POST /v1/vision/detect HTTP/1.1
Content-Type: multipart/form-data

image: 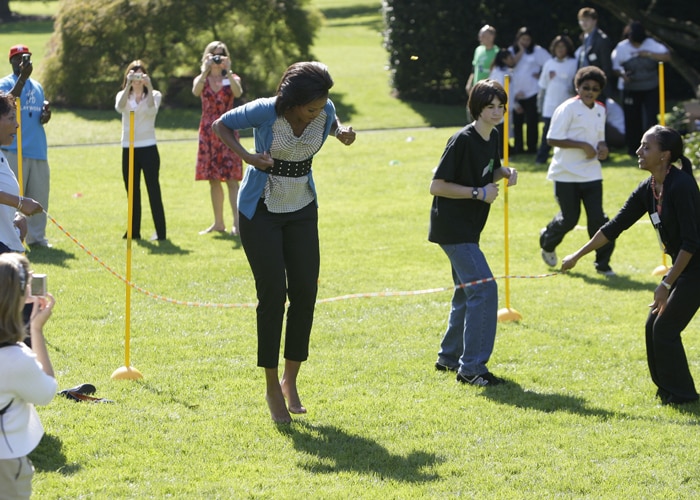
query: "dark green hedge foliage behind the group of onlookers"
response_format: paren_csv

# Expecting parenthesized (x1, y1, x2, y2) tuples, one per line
(382, 0, 700, 103)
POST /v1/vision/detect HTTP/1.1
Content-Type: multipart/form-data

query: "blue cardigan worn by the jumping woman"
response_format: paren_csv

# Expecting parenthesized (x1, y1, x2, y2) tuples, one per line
(221, 97, 335, 219)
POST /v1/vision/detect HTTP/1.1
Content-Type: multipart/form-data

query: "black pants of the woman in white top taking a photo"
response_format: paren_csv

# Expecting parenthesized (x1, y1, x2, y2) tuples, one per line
(122, 146, 166, 240)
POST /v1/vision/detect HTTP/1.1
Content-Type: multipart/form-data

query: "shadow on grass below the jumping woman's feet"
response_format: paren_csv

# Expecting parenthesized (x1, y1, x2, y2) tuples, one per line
(279, 421, 439, 483)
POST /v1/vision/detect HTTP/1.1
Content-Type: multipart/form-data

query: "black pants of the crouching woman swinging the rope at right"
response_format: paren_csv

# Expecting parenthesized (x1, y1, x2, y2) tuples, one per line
(646, 273, 700, 403)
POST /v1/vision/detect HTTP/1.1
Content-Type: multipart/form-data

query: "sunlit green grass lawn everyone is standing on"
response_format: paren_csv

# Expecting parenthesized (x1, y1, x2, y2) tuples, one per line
(5, 0, 700, 499)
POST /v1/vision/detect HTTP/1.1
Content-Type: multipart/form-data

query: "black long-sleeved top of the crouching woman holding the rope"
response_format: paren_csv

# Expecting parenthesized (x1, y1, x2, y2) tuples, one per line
(600, 167, 700, 272)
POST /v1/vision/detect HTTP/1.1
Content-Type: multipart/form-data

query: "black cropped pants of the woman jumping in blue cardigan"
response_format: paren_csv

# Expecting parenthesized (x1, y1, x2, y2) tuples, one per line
(240, 201, 320, 368)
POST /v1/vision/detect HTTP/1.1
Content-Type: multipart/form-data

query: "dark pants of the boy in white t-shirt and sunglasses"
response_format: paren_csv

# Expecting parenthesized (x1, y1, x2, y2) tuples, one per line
(540, 181, 615, 271)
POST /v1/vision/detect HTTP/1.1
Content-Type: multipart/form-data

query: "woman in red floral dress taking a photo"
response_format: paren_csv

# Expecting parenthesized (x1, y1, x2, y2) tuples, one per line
(192, 41, 243, 236)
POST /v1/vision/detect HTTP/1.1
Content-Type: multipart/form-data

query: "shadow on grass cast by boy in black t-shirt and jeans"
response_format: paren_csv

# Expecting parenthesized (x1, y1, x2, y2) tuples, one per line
(482, 380, 615, 419)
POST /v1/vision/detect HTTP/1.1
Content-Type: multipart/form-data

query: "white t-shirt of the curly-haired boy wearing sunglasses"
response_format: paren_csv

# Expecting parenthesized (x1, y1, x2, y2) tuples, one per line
(547, 96, 605, 182)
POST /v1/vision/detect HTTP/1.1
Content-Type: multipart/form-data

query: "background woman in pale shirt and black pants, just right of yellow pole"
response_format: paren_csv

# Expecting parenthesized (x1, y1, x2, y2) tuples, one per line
(510, 27, 550, 155)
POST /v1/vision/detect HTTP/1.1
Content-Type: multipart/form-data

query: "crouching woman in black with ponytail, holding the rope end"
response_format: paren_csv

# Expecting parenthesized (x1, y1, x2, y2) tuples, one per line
(561, 125, 700, 404)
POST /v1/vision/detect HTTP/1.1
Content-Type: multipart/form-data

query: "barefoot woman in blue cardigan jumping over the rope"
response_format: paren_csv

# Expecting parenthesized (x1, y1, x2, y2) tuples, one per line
(212, 62, 355, 423)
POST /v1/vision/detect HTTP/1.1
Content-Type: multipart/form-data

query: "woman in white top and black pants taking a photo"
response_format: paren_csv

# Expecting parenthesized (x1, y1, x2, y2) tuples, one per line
(114, 60, 166, 240)
